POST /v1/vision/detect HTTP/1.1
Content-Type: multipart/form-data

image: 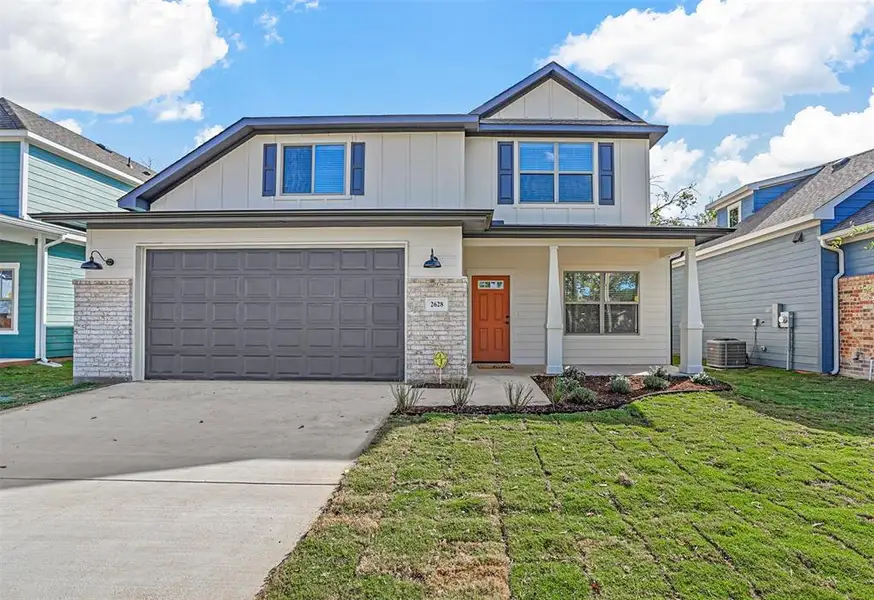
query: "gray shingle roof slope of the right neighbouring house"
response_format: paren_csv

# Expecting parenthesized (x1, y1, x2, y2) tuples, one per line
(703, 149, 874, 247)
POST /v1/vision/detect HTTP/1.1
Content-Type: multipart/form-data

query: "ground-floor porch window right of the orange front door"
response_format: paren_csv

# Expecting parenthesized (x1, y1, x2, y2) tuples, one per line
(564, 271, 640, 334)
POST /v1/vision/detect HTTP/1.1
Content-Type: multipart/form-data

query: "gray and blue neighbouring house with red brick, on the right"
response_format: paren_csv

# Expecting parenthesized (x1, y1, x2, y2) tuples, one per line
(672, 150, 874, 377)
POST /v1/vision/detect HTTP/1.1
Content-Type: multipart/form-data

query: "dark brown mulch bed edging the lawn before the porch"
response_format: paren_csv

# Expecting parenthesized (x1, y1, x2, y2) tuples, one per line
(392, 375, 731, 416)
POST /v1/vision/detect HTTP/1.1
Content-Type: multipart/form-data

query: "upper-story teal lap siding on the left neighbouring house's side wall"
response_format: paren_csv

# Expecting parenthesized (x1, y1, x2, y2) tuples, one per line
(27, 144, 132, 213)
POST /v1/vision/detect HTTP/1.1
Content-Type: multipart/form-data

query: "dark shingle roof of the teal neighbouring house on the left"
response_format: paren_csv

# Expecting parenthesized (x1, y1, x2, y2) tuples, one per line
(0, 98, 155, 181)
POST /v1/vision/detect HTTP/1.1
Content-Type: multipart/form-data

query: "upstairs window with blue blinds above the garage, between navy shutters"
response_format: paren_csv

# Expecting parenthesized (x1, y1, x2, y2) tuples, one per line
(282, 144, 346, 194)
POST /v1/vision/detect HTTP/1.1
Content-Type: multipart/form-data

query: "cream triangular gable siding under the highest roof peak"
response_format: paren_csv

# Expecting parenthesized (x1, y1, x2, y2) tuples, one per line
(488, 79, 612, 120)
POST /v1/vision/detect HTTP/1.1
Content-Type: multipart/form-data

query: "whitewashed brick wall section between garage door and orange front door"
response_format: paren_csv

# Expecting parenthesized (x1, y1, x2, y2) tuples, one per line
(406, 277, 468, 380)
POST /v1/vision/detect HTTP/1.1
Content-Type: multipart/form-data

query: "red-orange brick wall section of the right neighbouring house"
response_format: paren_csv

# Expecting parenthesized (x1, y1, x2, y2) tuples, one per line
(838, 274, 874, 378)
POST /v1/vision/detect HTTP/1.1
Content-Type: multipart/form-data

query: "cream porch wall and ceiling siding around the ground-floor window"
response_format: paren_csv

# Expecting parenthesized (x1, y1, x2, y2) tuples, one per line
(464, 246, 670, 367)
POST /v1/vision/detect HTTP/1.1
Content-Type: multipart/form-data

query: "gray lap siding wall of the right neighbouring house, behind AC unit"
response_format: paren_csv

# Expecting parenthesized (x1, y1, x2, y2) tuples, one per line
(671, 227, 822, 372)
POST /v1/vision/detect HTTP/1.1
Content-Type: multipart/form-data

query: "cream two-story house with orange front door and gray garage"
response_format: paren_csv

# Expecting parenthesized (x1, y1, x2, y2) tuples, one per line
(34, 64, 728, 380)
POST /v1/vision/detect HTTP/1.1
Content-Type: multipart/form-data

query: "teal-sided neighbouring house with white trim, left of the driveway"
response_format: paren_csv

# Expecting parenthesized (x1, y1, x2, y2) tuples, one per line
(0, 98, 152, 360)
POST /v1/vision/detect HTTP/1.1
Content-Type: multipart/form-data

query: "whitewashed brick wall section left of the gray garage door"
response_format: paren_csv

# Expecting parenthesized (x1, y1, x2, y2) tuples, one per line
(73, 279, 133, 383)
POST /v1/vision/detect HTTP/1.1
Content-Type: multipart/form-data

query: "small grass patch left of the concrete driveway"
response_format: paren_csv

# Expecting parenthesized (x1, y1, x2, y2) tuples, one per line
(0, 361, 97, 410)
